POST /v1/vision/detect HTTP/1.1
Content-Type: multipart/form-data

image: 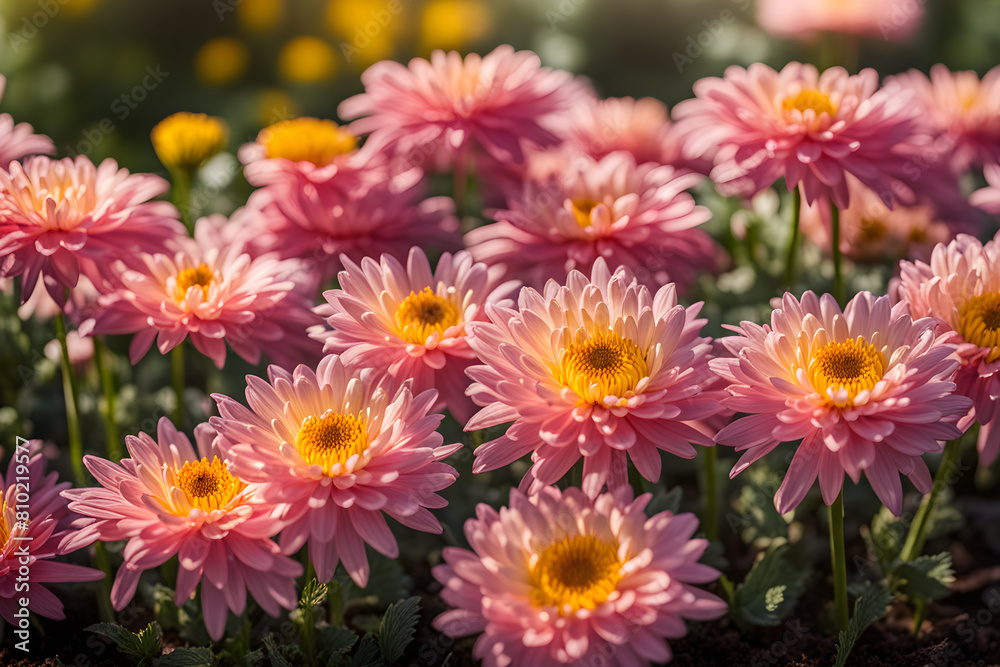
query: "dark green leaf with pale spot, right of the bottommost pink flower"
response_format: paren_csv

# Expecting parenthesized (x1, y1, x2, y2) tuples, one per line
(732, 545, 809, 625)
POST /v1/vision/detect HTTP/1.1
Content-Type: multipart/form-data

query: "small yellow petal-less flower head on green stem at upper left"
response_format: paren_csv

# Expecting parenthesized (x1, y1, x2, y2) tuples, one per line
(149, 111, 229, 170)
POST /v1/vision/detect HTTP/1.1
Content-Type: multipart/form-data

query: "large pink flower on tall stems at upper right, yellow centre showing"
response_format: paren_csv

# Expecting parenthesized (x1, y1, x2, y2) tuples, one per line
(674, 62, 915, 209)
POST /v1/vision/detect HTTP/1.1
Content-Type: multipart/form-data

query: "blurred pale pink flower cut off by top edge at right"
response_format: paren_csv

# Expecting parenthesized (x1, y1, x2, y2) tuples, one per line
(757, 0, 924, 41)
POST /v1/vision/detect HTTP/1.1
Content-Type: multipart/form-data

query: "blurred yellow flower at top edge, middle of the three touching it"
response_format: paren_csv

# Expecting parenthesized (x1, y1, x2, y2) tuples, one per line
(326, 0, 396, 68)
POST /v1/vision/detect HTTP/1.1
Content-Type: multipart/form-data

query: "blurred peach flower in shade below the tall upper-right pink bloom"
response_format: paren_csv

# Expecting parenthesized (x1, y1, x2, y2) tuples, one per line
(800, 176, 969, 264)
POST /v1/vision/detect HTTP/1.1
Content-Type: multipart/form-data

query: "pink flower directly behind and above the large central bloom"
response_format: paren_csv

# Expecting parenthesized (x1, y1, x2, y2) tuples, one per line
(465, 152, 717, 289)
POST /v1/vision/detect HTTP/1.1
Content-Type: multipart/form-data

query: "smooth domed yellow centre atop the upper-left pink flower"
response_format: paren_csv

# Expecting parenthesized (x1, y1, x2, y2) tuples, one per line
(257, 118, 358, 167)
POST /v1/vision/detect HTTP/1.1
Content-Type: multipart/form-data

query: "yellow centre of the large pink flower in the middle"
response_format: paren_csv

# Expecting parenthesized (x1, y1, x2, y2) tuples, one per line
(556, 331, 647, 403)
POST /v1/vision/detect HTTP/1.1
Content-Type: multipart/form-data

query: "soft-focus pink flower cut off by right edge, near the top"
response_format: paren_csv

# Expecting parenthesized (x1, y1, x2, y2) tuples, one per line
(885, 63, 1000, 173)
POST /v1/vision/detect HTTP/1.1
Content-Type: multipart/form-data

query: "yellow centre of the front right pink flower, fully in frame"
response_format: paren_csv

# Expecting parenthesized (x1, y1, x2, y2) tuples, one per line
(807, 336, 885, 408)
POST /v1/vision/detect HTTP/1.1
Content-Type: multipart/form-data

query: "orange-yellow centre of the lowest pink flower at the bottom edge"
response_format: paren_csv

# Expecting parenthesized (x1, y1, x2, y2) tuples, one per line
(530, 535, 622, 614)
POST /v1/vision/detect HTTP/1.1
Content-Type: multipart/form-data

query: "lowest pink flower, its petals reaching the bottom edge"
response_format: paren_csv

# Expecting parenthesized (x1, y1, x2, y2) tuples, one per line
(433, 487, 726, 667)
